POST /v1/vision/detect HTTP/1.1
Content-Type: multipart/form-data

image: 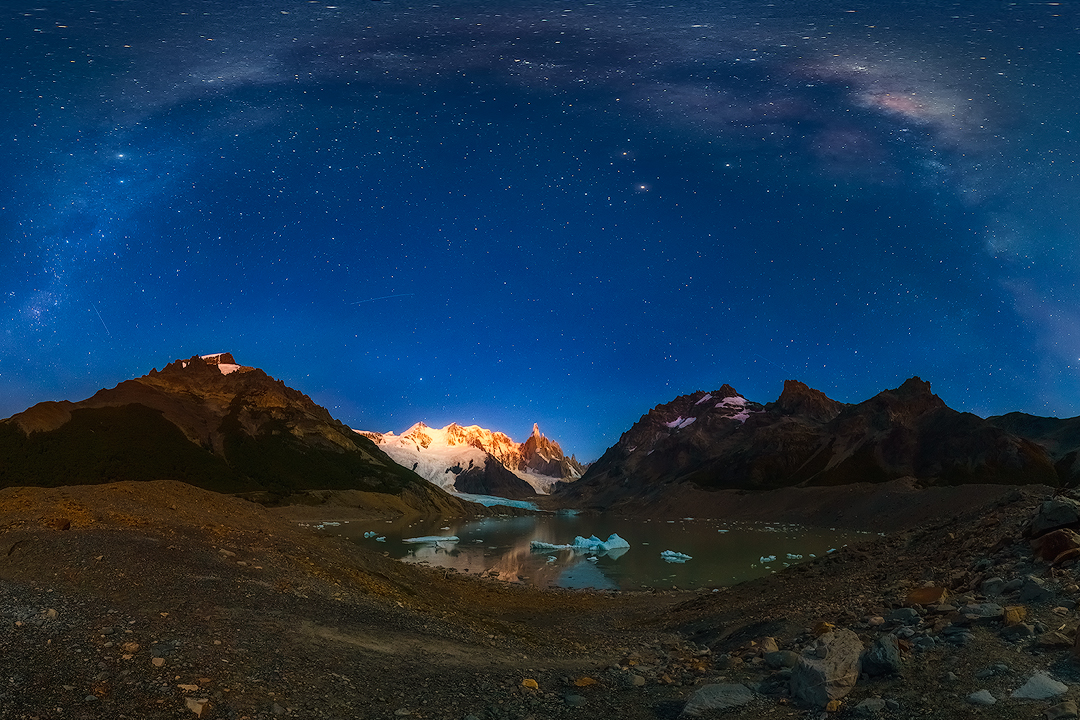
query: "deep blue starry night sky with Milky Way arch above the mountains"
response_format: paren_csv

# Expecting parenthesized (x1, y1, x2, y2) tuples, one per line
(0, 0, 1080, 460)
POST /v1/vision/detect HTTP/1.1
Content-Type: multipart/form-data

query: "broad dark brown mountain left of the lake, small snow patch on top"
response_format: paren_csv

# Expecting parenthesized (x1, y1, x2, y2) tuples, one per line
(0, 353, 438, 505)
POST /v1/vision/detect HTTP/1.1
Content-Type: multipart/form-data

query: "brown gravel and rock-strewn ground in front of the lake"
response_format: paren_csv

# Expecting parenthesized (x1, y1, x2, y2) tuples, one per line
(6, 481, 1080, 720)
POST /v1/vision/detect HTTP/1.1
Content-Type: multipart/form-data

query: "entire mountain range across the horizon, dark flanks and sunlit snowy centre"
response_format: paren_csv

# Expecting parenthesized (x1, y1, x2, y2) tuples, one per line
(0, 353, 1080, 513)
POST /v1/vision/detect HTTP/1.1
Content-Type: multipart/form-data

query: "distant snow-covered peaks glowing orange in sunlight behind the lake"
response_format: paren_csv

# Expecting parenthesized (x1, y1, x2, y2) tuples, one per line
(362, 422, 583, 500)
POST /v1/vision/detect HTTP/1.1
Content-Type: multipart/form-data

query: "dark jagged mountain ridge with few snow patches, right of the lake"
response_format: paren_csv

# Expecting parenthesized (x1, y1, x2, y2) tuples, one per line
(557, 377, 1080, 507)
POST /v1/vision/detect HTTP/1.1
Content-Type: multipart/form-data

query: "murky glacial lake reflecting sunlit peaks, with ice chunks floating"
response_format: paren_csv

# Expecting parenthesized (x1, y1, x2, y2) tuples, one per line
(313, 514, 870, 590)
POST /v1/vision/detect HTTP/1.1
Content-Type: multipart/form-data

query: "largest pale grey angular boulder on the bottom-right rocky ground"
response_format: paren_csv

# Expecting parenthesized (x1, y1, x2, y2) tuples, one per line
(791, 629, 863, 708)
